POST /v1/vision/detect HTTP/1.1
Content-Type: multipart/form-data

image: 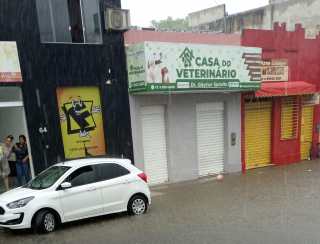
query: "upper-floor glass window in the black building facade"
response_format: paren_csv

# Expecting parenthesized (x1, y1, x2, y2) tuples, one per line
(37, 0, 102, 43)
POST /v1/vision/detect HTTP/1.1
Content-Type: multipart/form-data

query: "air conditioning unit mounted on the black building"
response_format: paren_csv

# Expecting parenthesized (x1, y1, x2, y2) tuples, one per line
(105, 8, 130, 31)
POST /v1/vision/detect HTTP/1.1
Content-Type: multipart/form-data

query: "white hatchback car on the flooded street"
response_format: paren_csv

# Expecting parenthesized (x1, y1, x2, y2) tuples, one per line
(0, 158, 151, 233)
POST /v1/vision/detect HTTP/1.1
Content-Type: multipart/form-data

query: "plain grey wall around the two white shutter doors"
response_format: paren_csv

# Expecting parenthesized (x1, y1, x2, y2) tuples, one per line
(130, 93, 241, 182)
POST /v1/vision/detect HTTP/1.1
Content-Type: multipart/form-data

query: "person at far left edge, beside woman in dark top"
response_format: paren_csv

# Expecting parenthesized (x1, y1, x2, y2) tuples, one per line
(0, 136, 12, 191)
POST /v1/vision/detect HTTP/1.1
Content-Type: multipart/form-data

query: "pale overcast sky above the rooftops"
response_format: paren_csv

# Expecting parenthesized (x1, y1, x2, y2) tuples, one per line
(121, 0, 269, 27)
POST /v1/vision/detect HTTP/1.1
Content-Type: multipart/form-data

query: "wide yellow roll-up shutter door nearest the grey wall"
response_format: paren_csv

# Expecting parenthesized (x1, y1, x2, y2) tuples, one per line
(245, 100, 272, 169)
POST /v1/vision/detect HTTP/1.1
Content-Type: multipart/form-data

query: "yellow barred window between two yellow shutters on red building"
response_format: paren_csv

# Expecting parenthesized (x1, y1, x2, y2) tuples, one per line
(281, 97, 299, 140)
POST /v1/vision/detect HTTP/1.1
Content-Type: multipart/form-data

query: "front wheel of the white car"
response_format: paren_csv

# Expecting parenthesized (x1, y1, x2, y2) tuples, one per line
(33, 210, 57, 233)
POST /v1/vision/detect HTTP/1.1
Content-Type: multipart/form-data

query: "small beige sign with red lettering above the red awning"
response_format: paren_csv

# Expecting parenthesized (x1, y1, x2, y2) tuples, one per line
(262, 59, 289, 81)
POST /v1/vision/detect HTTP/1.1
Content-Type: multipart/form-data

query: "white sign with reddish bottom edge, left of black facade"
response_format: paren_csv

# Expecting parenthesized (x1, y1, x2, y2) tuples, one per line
(0, 42, 22, 83)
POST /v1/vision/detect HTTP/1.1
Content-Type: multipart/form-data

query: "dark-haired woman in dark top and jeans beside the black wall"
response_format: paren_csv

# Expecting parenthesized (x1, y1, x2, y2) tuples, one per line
(13, 135, 30, 186)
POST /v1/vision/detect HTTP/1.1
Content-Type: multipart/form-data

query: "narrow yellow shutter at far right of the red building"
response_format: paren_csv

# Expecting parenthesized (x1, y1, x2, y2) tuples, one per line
(300, 96, 314, 160)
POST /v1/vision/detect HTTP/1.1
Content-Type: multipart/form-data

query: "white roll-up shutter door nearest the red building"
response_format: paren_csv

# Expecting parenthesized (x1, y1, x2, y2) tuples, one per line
(197, 103, 224, 176)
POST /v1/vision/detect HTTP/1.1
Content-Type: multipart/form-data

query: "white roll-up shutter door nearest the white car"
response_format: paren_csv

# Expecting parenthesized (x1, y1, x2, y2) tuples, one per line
(141, 106, 168, 185)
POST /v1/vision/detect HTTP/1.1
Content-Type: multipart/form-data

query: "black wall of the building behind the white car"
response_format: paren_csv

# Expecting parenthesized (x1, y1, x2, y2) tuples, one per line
(0, 0, 133, 173)
